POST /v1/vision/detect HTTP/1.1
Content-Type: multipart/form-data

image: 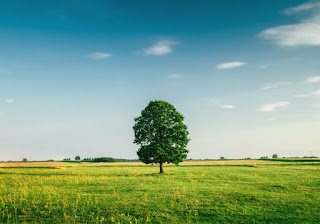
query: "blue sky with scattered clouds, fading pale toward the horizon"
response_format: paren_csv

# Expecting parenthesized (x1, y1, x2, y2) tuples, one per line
(0, 0, 320, 161)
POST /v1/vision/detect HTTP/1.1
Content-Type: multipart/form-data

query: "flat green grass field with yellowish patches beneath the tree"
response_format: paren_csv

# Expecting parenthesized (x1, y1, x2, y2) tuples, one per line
(0, 160, 320, 223)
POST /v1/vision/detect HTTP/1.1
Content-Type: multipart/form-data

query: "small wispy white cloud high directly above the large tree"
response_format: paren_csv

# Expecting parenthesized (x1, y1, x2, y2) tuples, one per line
(140, 40, 179, 56)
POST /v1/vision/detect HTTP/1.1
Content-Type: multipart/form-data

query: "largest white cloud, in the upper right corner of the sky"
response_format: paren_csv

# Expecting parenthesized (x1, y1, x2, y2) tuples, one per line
(259, 1, 320, 47)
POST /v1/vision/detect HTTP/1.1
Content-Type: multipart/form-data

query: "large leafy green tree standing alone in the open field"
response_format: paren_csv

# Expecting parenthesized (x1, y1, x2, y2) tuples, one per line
(133, 100, 190, 173)
